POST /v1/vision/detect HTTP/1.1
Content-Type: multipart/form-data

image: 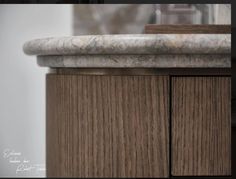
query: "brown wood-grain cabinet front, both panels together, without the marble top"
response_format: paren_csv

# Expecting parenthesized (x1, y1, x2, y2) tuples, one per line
(47, 74, 231, 178)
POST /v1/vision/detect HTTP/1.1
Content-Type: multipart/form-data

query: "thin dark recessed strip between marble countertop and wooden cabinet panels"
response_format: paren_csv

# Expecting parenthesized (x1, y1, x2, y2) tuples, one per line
(50, 68, 231, 76)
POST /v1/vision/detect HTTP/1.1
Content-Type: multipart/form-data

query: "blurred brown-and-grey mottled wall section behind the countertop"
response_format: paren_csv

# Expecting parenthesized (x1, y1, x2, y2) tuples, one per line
(74, 4, 155, 35)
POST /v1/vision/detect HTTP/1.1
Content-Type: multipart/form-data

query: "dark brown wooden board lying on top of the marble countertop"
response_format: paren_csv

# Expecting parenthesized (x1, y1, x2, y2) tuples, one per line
(145, 24, 231, 34)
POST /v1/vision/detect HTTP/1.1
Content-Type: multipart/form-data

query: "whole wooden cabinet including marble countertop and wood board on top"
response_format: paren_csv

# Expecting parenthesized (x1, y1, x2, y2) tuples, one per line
(23, 24, 231, 178)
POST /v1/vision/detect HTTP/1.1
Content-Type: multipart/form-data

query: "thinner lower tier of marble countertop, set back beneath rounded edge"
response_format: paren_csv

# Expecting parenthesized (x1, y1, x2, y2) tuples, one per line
(37, 54, 231, 68)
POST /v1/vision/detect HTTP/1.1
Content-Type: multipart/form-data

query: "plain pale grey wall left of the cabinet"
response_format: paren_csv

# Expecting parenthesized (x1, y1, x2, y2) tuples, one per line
(0, 5, 72, 177)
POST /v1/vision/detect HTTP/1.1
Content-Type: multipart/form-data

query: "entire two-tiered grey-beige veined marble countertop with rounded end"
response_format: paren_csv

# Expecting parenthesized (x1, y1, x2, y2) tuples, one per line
(23, 34, 231, 68)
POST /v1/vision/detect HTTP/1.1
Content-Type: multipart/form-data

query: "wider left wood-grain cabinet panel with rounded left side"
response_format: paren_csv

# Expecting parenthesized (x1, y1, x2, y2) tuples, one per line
(46, 74, 169, 177)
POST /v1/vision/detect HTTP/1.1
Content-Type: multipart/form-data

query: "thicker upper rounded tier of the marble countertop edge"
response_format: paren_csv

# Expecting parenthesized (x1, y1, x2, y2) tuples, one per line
(23, 34, 231, 55)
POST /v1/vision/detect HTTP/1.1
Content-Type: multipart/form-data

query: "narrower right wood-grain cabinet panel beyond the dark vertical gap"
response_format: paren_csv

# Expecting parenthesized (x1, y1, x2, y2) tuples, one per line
(171, 77, 231, 176)
